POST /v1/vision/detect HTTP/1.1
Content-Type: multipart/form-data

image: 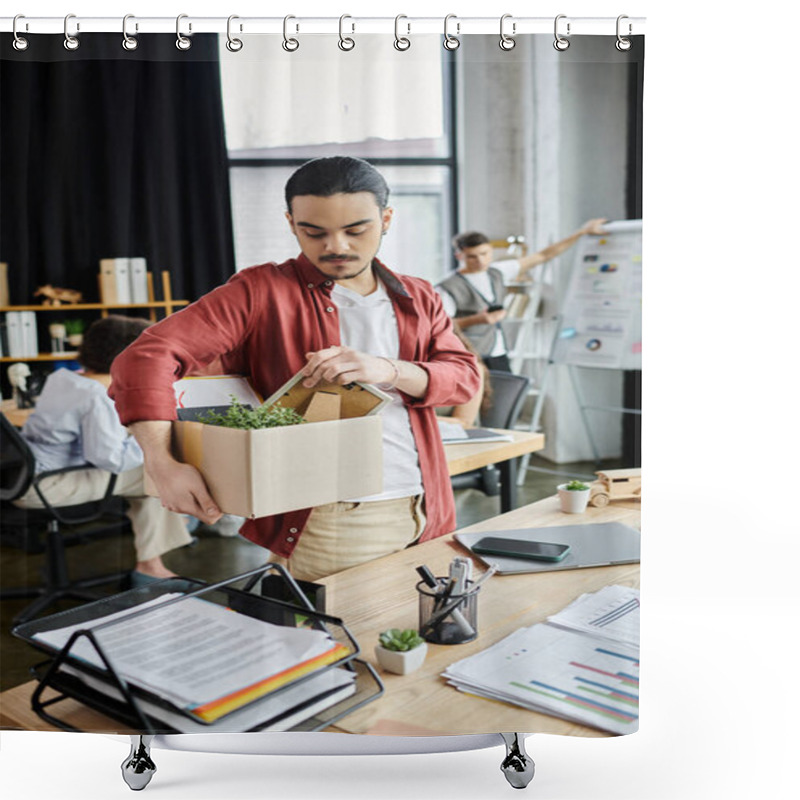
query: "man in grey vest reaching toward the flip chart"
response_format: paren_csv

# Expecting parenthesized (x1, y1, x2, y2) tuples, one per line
(436, 219, 606, 372)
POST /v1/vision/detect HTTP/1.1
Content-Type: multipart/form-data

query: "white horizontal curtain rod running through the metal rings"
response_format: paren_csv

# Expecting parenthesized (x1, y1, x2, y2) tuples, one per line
(0, 14, 645, 38)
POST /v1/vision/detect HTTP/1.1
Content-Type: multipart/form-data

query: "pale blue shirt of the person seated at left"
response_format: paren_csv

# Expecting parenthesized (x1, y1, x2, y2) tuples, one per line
(22, 369, 143, 473)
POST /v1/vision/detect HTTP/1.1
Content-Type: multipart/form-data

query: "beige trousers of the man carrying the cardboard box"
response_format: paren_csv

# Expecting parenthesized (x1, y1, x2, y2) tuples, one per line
(270, 495, 425, 581)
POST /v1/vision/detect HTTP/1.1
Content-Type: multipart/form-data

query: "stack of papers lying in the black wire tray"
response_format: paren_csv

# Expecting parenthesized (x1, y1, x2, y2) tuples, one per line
(35, 594, 355, 733)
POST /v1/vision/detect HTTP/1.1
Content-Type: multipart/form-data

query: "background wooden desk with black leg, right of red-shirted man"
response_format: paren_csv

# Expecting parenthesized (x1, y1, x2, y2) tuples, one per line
(444, 430, 544, 513)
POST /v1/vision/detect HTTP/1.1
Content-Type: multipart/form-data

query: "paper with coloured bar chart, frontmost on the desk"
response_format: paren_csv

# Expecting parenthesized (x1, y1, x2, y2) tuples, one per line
(444, 584, 639, 734)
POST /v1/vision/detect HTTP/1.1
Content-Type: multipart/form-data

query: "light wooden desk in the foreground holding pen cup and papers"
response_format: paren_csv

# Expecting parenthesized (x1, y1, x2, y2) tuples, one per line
(0, 497, 640, 736)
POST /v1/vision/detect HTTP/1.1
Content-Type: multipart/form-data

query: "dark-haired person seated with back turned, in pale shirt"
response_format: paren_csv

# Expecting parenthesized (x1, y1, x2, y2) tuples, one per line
(15, 316, 192, 586)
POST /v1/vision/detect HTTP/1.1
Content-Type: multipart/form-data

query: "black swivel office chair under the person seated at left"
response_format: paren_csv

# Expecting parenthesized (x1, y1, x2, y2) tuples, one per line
(0, 414, 130, 625)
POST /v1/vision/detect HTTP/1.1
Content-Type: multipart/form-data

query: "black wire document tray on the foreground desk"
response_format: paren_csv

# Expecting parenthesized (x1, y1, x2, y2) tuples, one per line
(13, 564, 383, 734)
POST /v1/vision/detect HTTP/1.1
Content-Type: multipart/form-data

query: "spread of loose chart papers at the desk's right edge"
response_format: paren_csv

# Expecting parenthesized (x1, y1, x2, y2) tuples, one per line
(443, 586, 639, 734)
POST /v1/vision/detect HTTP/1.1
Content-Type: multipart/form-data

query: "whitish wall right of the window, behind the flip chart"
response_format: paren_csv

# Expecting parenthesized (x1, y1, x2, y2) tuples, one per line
(459, 36, 628, 463)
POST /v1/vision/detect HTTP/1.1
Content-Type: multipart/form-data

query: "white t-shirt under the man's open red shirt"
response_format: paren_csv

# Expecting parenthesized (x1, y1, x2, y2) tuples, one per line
(331, 281, 422, 502)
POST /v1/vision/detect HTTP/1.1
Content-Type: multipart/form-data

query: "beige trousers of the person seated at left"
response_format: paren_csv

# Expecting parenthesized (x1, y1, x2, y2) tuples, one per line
(14, 467, 192, 561)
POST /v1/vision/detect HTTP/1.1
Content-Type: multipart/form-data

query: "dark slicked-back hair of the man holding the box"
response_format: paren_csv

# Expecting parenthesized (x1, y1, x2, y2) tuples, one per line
(285, 156, 389, 214)
